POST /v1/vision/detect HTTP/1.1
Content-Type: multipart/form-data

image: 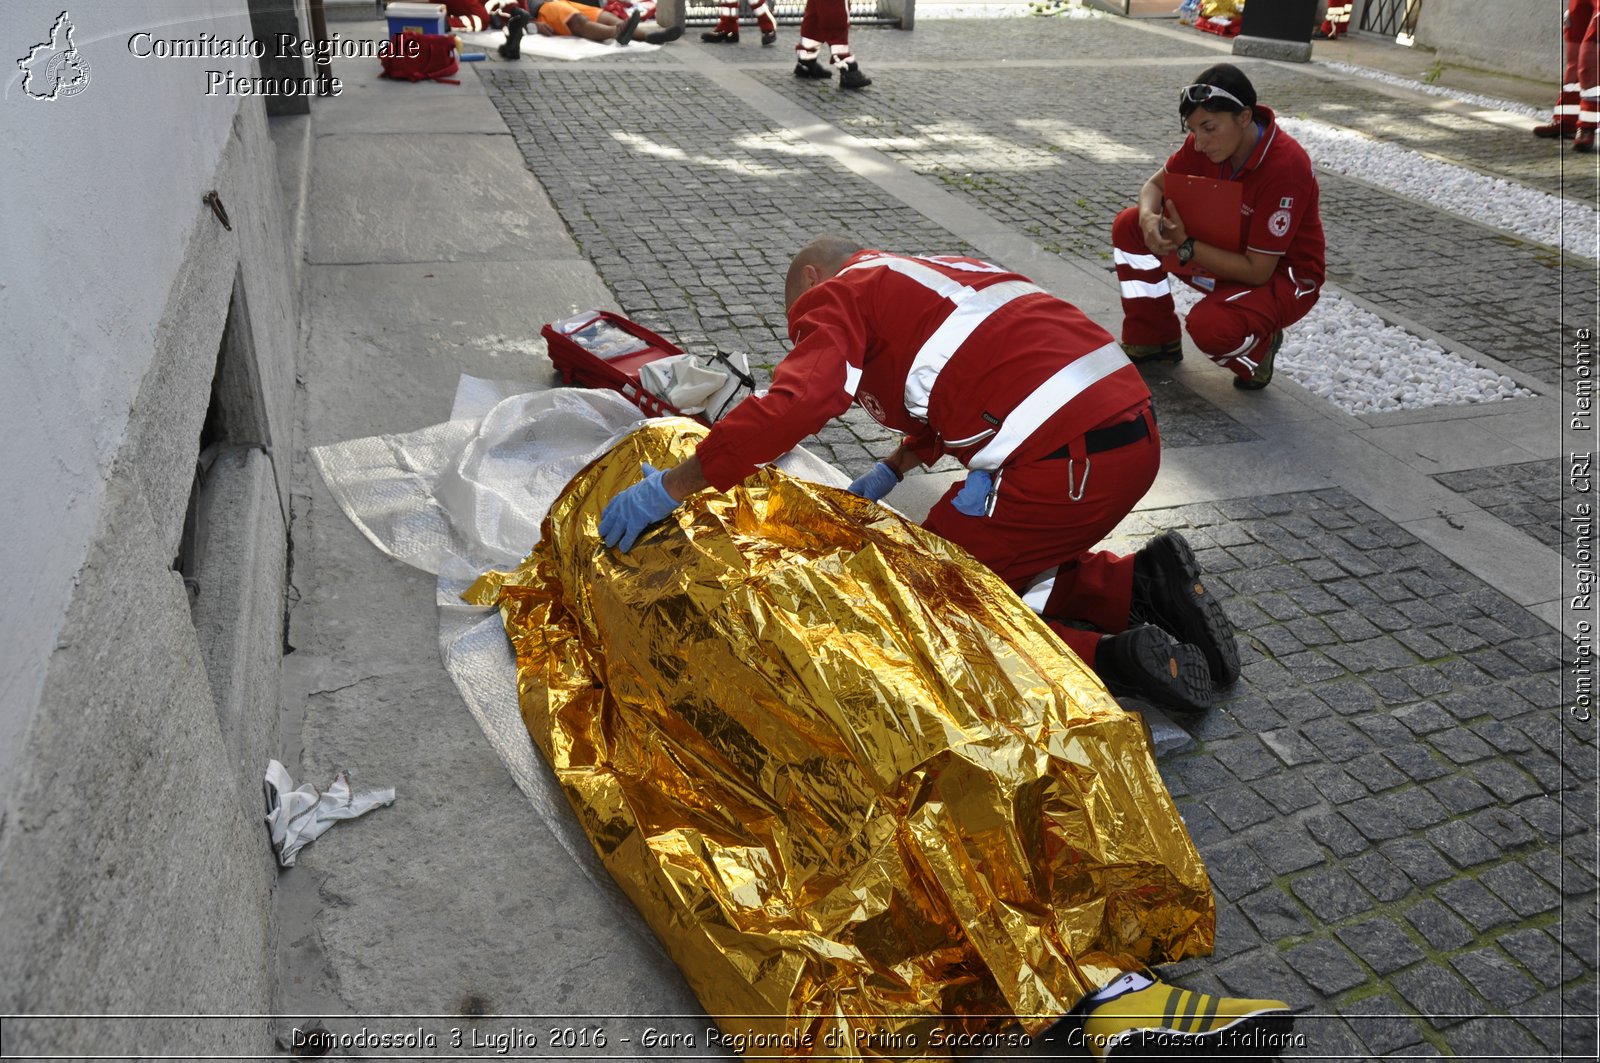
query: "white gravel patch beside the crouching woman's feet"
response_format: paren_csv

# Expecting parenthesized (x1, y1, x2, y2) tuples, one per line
(1173, 279, 1533, 416)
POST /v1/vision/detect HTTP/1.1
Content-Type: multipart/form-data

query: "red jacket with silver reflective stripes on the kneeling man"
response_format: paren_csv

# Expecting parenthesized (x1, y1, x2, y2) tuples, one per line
(698, 251, 1150, 490)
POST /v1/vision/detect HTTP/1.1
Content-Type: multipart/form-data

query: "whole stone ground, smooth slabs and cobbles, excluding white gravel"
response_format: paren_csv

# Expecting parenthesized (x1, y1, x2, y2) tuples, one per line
(280, 10, 1597, 1060)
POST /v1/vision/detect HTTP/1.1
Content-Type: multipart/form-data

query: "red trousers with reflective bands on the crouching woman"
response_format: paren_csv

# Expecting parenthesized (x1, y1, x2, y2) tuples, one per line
(1110, 207, 1322, 379)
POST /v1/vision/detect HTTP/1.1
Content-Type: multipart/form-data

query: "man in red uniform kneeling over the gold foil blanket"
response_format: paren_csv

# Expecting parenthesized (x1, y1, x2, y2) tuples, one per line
(600, 237, 1238, 711)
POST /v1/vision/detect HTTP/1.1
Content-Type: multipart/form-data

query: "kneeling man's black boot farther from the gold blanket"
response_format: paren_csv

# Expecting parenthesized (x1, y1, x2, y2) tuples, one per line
(1128, 532, 1238, 687)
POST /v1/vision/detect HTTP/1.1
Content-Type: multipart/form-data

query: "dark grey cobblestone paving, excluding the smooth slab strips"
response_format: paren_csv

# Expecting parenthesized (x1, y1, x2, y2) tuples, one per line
(483, 19, 1597, 1058)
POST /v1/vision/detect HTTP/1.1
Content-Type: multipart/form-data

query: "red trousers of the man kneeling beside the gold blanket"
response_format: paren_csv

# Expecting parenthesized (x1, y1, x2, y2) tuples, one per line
(922, 405, 1162, 668)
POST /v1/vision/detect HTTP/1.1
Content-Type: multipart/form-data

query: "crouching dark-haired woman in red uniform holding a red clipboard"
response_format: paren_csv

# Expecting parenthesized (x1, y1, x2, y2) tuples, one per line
(1110, 62, 1326, 391)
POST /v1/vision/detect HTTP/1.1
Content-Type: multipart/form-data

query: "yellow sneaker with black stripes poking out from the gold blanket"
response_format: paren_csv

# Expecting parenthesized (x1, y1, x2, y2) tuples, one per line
(1082, 975, 1294, 1060)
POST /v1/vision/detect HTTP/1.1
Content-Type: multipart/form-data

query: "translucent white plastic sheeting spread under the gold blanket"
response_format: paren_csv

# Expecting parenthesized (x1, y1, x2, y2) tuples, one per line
(310, 376, 850, 902)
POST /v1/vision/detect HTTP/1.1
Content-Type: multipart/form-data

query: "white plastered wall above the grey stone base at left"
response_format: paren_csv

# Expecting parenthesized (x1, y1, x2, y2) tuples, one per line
(0, 0, 254, 810)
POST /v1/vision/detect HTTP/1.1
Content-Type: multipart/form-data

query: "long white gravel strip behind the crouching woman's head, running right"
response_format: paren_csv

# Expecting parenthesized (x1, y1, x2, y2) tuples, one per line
(1280, 118, 1600, 259)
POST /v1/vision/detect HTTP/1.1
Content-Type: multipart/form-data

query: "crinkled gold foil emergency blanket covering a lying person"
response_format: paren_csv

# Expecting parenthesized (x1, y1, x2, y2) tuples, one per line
(467, 419, 1214, 1060)
